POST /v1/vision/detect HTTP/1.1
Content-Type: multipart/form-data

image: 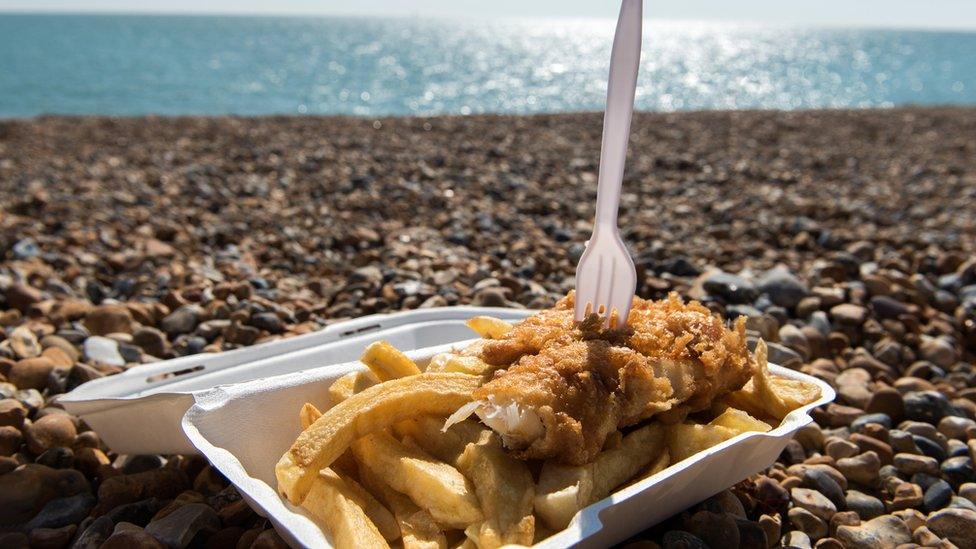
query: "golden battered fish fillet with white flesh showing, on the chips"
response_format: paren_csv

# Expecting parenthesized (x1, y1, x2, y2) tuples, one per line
(449, 293, 751, 465)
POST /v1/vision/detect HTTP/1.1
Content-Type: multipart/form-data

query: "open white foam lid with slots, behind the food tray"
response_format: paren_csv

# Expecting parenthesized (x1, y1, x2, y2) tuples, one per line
(58, 307, 533, 454)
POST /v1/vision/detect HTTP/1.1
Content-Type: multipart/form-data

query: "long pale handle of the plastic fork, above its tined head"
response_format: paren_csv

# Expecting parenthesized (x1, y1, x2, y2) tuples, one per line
(595, 0, 643, 229)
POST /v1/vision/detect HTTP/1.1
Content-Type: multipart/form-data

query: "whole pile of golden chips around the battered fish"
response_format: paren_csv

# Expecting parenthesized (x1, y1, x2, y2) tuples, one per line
(275, 326, 820, 549)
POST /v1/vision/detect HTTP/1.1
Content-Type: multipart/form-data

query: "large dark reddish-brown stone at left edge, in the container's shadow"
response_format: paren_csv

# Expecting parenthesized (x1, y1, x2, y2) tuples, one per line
(0, 463, 91, 524)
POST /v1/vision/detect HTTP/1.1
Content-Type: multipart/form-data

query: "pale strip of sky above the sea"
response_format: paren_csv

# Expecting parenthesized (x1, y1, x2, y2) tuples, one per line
(0, 0, 976, 30)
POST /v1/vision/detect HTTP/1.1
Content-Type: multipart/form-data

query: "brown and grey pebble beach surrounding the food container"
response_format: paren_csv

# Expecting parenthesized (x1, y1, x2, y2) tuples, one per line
(0, 108, 976, 549)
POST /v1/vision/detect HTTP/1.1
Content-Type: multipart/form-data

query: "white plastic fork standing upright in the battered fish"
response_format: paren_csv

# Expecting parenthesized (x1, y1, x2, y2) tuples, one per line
(576, 0, 643, 326)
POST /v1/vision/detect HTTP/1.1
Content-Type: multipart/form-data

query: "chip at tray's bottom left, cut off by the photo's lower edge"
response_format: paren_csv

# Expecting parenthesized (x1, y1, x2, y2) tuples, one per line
(302, 469, 389, 549)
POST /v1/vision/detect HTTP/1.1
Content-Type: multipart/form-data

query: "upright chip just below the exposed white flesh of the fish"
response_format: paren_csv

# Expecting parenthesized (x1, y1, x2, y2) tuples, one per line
(457, 431, 535, 549)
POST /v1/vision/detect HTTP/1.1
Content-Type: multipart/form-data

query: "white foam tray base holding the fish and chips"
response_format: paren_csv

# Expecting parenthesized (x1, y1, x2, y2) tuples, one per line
(183, 344, 834, 549)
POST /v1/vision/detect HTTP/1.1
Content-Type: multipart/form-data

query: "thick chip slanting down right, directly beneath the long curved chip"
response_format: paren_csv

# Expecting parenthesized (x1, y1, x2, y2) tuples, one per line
(352, 432, 484, 528)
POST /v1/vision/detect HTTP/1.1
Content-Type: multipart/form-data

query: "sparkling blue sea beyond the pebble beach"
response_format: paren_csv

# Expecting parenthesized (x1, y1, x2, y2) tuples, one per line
(0, 14, 976, 117)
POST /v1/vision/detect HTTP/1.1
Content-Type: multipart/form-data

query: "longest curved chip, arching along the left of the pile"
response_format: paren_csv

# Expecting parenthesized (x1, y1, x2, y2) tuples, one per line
(275, 373, 481, 504)
